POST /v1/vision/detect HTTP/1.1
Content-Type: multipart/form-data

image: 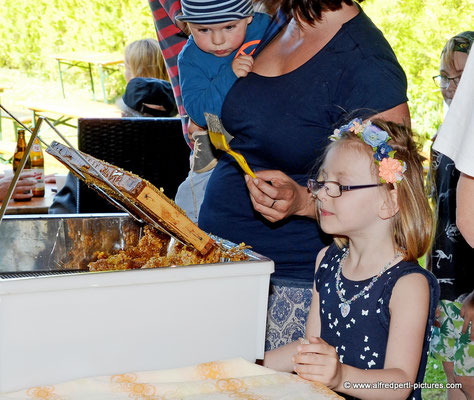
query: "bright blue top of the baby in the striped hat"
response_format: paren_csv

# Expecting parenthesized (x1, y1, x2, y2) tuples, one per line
(178, 49, 237, 127)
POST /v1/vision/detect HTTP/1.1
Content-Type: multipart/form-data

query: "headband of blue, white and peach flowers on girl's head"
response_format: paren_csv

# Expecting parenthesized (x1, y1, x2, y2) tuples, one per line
(329, 118, 407, 183)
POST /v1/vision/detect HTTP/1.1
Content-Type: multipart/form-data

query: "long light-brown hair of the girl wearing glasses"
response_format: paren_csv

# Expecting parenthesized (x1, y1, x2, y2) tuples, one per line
(316, 119, 434, 261)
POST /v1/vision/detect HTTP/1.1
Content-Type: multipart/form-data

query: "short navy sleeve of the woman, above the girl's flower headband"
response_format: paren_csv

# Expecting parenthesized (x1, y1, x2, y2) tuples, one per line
(338, 56, 408, 118)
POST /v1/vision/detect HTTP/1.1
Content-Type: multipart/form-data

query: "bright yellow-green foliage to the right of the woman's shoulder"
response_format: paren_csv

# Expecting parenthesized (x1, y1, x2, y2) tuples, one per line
(362, 0, 474, 144)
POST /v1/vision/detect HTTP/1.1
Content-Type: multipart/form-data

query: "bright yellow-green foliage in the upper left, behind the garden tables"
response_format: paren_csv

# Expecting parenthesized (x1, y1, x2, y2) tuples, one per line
(0, 0, 156, 95)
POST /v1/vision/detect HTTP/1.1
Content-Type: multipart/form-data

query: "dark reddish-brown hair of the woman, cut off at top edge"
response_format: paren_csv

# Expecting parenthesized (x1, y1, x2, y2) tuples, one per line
(280, 0, 363, 24)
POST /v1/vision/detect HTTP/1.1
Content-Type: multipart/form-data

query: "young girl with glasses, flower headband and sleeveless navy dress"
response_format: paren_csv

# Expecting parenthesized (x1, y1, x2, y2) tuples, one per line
(265, 119, 439, 399)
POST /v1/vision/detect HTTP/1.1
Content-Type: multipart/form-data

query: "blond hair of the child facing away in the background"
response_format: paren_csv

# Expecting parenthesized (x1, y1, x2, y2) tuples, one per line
(124, 38, 169, 81)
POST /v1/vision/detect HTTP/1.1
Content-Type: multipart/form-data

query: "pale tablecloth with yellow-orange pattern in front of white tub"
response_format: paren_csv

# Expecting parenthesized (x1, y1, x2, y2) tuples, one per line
(0, 358, 341, 400)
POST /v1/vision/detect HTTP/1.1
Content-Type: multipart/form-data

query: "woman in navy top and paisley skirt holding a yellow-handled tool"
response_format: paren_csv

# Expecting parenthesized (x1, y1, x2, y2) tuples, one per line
(199, 0, 409, 350)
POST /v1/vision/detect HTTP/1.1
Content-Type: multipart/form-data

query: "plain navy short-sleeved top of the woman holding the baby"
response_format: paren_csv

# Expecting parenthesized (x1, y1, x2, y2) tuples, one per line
(199, 7, 407, 287)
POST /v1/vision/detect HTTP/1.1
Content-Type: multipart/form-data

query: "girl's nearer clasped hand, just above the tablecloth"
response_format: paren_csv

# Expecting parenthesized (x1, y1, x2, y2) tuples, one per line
(293, 336, 342, 389)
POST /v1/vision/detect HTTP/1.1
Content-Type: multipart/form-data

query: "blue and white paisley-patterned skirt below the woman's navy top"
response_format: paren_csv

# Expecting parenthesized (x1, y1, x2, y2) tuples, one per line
(265, 281, 313, 351)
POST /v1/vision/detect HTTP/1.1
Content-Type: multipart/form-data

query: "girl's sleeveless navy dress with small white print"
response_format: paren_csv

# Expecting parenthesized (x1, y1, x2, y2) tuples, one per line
(315, 244, 439, 399)
